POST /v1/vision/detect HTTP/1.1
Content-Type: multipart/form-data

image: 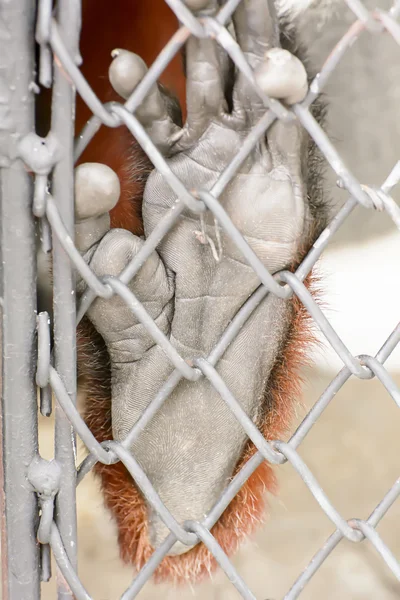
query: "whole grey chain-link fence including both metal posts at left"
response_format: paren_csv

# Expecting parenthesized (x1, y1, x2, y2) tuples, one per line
(0, 0, 400, 600)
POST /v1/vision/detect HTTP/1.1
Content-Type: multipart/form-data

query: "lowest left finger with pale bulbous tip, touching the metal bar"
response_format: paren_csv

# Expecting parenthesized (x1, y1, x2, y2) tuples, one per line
(75, 163, 121, 253)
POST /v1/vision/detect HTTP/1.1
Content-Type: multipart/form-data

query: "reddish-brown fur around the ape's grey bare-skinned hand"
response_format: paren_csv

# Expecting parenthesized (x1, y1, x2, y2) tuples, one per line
(77, 0, 324, 583)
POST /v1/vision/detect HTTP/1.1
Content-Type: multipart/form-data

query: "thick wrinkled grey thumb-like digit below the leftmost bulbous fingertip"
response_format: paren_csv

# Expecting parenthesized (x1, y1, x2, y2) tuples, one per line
(88, 229, 173, 354)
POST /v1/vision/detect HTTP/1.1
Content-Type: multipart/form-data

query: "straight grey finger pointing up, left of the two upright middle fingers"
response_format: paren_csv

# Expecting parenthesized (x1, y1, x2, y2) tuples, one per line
(185, 0, 227, 131)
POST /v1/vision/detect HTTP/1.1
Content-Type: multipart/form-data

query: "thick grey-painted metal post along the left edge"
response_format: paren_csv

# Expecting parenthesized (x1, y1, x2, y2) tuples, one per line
(0, 0, 40, 600)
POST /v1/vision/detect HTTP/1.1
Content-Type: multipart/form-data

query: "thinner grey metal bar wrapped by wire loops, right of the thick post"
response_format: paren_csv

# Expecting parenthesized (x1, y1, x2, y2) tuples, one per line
(51, 0, 80, 600)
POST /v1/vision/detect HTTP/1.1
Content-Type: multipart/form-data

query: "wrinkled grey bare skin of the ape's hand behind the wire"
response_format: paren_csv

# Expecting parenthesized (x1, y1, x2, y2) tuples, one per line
(77, 0, 311, 554)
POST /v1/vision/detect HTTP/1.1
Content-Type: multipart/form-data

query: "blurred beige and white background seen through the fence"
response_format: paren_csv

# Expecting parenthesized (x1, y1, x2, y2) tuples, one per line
(27, 0, 400, 600)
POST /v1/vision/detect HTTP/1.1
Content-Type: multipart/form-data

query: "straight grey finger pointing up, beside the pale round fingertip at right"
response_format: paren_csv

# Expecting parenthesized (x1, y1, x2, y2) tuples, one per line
(232, 0, 280, 115)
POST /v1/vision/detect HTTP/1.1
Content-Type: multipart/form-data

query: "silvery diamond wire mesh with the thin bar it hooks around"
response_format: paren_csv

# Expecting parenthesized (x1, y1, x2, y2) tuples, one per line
(0, 0, 400, 600)
